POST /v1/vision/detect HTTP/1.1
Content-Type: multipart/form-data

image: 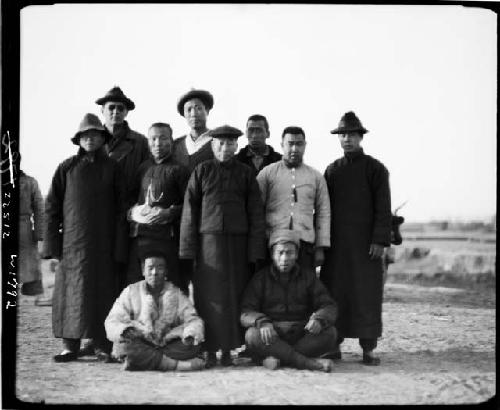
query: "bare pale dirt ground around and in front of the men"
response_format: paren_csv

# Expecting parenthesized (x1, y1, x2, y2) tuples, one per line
(16, 283, 496, 404)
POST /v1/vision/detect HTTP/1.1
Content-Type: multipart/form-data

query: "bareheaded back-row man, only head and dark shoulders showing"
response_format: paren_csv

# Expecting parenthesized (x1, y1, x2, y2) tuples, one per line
(236, 114, 281, 175)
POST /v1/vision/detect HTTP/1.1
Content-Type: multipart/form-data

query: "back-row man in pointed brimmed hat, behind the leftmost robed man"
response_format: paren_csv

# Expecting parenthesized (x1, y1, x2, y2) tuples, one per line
(96, 86, 149, 205)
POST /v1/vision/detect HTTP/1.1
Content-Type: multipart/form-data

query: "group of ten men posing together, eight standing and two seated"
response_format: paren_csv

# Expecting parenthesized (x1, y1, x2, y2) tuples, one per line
(42, 87, 391, 371)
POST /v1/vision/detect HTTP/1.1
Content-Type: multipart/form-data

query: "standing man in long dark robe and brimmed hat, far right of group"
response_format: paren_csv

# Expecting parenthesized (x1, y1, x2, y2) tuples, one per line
(320, 111, 391, 365)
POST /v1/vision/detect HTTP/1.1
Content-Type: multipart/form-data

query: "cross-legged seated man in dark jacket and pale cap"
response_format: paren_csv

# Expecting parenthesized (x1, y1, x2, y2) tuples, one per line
(241, 230, 337, 372)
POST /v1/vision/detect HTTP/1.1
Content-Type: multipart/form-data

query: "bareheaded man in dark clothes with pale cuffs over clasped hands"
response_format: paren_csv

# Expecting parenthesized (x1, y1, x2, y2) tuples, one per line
(127, 123, 189, 294)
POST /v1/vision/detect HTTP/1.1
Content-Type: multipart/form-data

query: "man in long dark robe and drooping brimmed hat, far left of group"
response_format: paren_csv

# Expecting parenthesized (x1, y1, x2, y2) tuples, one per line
(42, 114, 125, 362)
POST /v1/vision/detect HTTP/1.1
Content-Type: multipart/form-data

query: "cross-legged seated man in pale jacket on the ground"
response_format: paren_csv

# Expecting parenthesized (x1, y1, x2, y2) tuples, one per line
(104, 251, 205, 371)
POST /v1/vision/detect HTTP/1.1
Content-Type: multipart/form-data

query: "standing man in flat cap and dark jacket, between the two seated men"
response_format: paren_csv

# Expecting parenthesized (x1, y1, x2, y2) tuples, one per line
(179, 126, 265, 367)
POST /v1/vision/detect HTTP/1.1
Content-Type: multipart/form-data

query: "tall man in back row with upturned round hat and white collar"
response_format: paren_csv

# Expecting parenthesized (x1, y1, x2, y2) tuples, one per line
(172, 89, 214, 172)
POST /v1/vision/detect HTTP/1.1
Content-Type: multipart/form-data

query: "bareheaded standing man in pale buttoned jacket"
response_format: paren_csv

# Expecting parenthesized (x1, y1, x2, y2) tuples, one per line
(257, 127, 330, 272)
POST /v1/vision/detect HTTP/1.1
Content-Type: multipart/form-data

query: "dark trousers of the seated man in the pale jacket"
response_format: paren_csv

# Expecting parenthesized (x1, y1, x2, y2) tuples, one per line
(117, 339, 200, 370)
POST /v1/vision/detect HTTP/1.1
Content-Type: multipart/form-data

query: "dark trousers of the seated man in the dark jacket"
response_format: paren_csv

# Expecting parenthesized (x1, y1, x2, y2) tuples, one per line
(245, 322, 337, 369)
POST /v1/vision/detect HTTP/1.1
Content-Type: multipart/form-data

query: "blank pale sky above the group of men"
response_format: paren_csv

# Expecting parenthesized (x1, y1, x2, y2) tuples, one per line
(20, 4, 497, 221)
